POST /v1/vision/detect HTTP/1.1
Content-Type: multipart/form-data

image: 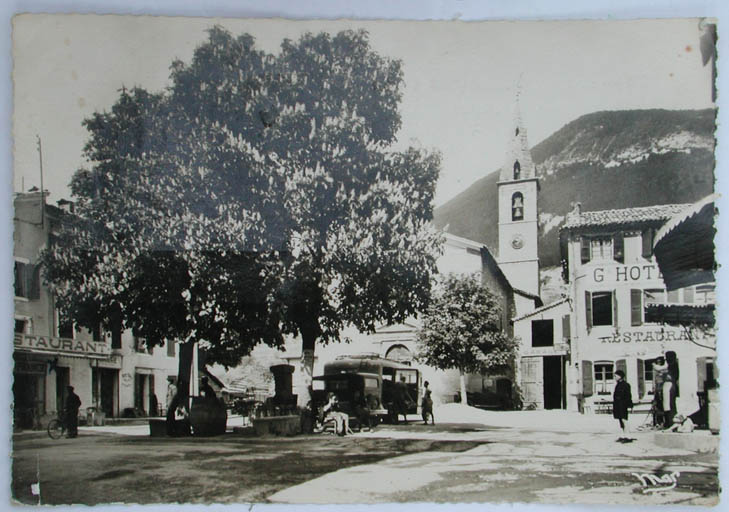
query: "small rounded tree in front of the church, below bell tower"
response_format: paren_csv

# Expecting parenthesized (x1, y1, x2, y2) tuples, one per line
(417, 274, 517, 404)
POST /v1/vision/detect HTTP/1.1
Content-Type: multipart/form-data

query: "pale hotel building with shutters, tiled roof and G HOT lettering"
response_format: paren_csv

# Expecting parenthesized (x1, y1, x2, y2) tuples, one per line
(555, 204, 716, 414)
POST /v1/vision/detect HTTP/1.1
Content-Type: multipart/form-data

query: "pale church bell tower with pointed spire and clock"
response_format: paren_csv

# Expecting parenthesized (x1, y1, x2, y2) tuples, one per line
(497, 99, 539, 295)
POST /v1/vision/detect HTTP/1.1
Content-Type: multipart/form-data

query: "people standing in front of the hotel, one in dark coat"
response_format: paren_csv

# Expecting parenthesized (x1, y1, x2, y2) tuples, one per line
(613, 352, 688, 442)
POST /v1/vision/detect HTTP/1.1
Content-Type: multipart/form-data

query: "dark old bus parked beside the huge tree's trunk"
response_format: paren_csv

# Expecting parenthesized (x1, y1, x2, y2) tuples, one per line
(314, 354, 420, 422)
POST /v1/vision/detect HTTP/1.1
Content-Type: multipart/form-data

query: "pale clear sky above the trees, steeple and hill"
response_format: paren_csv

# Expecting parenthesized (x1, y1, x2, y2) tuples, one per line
(13, 15, 711, 204)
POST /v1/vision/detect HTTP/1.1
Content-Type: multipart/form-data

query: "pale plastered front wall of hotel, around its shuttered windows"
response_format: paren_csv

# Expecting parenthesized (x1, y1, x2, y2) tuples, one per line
(568, 227, 716, 414)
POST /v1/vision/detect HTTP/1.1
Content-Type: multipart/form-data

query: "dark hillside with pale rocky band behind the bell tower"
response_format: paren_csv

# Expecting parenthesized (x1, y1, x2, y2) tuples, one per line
(435, 109, 715, 267)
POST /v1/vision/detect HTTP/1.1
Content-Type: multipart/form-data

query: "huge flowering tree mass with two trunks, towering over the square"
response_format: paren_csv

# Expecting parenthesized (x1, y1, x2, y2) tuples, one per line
(45, 27, 440, 406)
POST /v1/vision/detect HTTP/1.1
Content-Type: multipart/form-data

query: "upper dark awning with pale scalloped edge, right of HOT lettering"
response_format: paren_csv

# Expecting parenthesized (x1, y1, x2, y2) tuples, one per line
(653, 194, 717, 290)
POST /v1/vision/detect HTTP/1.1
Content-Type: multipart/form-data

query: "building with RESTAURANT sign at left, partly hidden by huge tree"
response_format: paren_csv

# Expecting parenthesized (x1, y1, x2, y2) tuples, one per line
(12, 191, 178, 428)
